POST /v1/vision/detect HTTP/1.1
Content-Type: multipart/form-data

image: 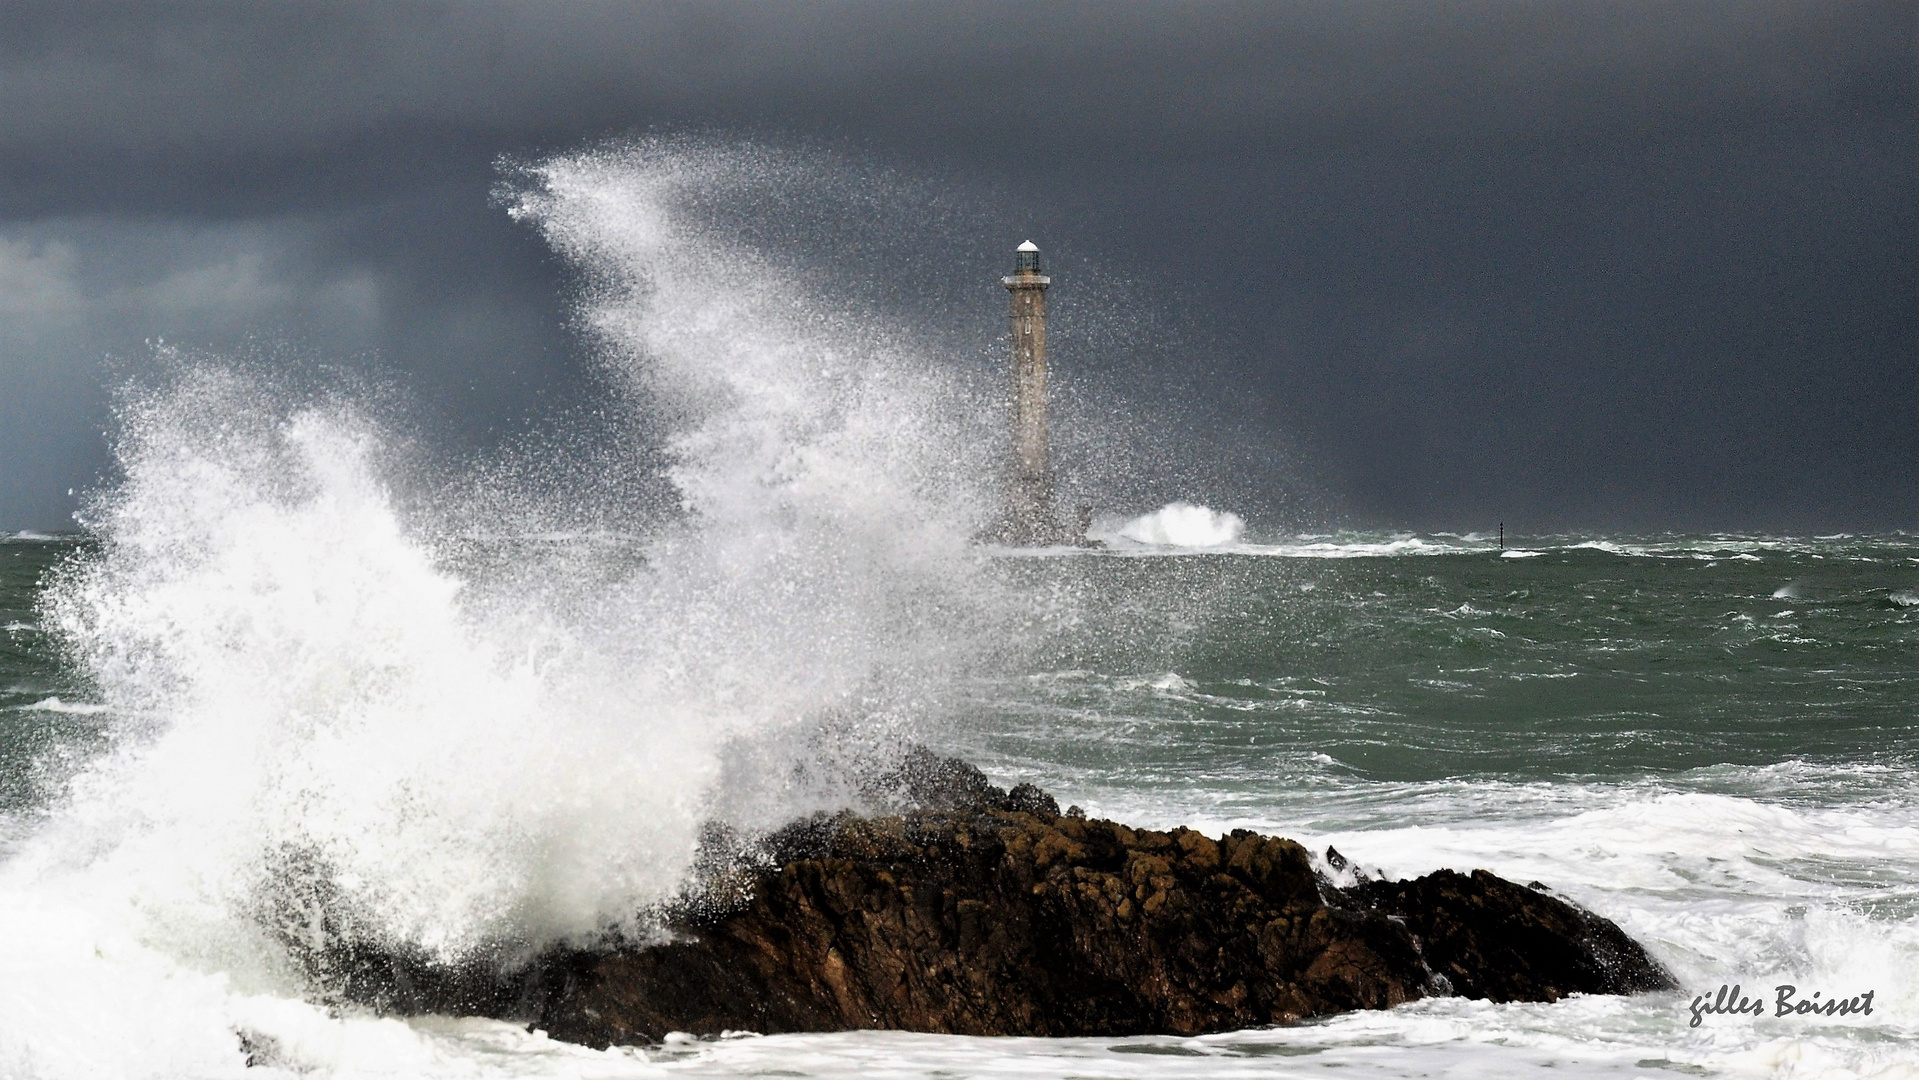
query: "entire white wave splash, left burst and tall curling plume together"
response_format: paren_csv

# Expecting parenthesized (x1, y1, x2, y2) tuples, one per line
(10, 146, 1019, 1074)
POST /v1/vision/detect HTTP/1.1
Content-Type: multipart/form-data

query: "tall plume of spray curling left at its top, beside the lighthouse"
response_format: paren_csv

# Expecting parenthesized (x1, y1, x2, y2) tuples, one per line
(501, 140, 1031, 827)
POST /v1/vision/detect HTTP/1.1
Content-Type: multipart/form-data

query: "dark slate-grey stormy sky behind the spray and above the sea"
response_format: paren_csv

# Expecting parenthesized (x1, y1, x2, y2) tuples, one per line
(0, 4, 1919, 528)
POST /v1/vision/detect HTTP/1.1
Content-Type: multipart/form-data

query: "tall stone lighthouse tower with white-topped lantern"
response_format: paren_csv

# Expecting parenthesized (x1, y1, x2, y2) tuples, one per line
(1004, 240, 1069, 543)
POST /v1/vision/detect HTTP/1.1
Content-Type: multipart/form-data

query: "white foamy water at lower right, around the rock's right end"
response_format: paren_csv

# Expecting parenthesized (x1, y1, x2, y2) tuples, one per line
(1036, 763, 1919, 1076)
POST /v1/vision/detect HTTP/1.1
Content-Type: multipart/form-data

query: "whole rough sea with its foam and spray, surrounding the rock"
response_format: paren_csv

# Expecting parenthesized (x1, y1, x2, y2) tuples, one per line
(0, 144, 1919, 1080)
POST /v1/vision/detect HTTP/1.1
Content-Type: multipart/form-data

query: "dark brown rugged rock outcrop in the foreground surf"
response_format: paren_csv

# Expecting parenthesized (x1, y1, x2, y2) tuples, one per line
(299, 758, 1671, 1045)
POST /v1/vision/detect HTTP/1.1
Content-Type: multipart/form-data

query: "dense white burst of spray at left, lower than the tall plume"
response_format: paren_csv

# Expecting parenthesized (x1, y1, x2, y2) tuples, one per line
(52, 368, 716, 953)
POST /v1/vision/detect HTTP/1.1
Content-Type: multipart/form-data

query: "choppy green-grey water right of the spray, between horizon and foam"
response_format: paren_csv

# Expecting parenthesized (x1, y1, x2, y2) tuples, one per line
(947, 537, 1919, 798)
